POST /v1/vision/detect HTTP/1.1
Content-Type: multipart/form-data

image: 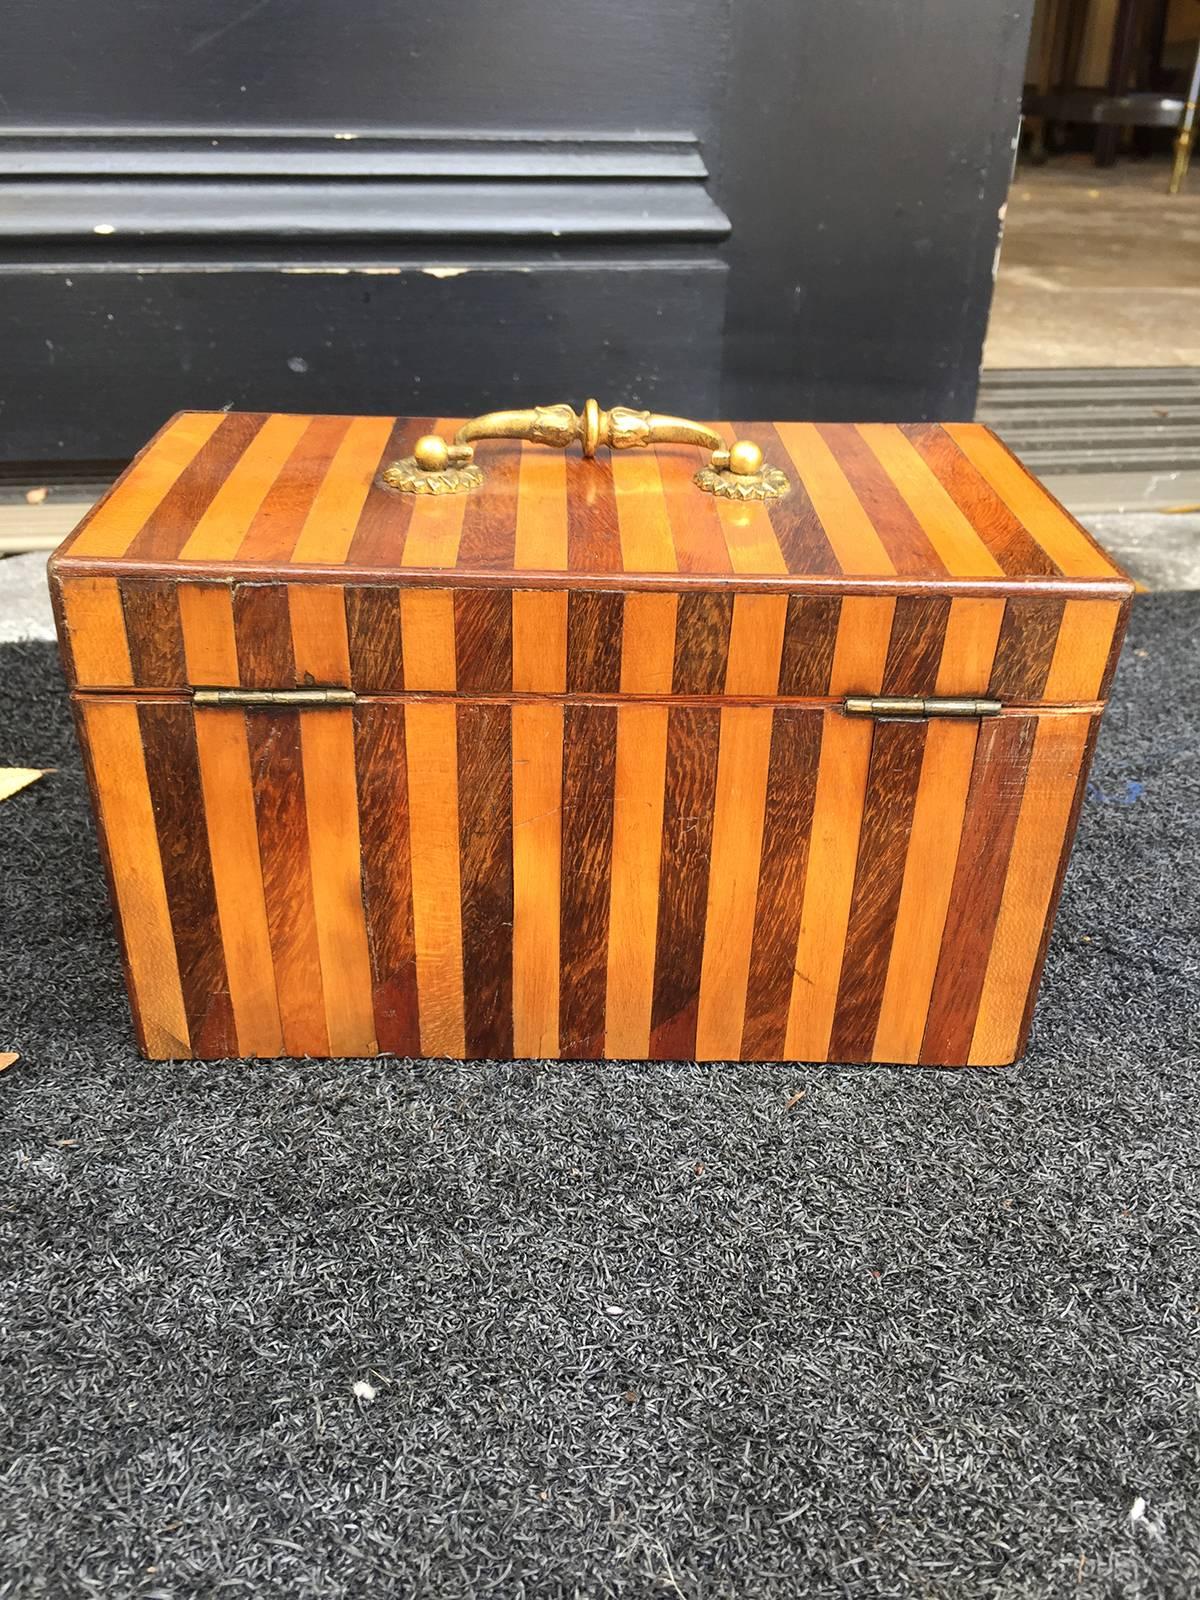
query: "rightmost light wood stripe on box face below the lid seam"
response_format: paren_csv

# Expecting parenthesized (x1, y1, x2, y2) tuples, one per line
(970, 712, 1091, 1066)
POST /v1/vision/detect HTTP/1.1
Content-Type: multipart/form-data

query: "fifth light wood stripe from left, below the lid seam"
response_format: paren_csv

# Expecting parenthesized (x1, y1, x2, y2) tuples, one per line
(512, 704, 563, 1058)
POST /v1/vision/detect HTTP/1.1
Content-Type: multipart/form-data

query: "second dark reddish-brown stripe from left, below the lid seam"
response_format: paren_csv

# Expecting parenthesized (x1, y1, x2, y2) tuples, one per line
(244, 710, 330, 1056)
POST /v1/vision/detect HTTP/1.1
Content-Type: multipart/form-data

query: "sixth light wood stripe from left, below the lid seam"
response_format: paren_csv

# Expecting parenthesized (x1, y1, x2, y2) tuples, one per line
(605, 704, 669, 1061)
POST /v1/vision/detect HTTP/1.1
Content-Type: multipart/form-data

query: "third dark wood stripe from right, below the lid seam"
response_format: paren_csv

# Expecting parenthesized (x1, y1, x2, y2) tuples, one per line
(742, 710, 821, 1061)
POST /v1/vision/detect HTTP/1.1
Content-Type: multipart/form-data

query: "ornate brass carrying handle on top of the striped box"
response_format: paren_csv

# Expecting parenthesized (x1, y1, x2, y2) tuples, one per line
(382, 400, 790, 501)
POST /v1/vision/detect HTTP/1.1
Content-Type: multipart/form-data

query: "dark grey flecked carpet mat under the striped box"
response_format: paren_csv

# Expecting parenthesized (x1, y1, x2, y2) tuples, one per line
(0, 595, 1200, 1600)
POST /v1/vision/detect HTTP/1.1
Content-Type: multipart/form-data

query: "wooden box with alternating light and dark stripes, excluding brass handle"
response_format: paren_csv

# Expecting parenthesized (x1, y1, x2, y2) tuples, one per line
(51, 413, 1131, 1064)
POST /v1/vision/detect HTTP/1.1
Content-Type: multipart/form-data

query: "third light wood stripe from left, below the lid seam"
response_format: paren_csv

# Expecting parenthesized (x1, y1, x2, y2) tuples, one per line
(299, 709, 376, 1056)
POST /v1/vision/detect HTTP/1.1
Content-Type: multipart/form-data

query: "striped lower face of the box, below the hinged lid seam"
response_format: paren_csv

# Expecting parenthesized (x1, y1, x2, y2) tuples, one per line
(78, 694, 1096, 1066)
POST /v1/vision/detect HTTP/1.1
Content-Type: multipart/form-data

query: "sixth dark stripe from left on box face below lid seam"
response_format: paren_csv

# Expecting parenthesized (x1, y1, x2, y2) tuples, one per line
(650, 707, 720, 1061)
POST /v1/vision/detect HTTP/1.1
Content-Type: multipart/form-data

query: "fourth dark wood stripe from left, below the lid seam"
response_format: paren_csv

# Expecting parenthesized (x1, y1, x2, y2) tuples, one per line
(458, 704, 512, 1061)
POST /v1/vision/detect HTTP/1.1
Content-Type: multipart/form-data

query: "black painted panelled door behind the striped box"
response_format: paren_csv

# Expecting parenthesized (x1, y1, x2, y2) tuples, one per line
(0, 0, 1030, 461)
